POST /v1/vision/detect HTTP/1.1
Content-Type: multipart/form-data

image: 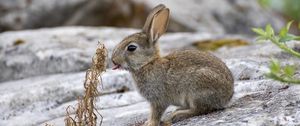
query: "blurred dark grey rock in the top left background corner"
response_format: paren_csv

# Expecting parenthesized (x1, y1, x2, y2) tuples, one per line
(0, 0, 86, 31)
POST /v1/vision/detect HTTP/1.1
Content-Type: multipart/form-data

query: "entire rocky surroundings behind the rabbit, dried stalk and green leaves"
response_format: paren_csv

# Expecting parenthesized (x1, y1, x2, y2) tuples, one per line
(0, 0, 300, 126)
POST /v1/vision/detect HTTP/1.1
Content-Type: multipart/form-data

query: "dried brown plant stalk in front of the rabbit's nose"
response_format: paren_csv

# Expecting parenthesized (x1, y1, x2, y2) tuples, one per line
(65, 44, 107, 126)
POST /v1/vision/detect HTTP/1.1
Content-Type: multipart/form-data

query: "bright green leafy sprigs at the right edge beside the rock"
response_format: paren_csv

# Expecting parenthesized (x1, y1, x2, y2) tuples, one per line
(252, 21, 300, 84)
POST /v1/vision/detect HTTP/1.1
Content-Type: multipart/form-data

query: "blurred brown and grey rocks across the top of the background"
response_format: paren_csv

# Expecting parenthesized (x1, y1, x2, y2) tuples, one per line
(0, 0, 284, 34)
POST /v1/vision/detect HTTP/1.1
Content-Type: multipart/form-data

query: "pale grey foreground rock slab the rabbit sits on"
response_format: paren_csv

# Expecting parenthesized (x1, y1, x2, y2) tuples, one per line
(0, 40, 300, 126)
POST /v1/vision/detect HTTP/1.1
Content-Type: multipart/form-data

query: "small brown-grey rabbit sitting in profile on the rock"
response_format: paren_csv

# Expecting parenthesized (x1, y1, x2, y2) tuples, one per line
(112, 4, 234, 126)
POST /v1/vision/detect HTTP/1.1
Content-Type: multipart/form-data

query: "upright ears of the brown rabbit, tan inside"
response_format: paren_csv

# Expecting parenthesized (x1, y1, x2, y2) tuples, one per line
(143, 4, 170, 43)
